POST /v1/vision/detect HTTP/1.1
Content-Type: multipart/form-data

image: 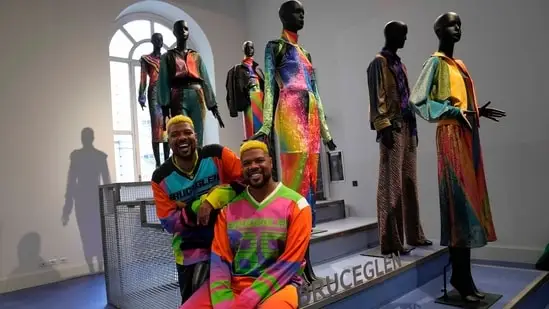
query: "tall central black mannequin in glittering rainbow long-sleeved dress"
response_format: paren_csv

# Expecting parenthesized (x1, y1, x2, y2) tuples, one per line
(249, 1, 336, 282)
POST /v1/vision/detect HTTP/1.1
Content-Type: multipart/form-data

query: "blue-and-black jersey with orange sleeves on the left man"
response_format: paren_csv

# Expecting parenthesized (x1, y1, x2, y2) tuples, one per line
(151, 144, 241, 265)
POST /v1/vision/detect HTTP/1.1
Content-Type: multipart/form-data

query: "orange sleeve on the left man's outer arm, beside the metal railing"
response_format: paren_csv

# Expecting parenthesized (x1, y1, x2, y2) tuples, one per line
(151, 181, 185, 234)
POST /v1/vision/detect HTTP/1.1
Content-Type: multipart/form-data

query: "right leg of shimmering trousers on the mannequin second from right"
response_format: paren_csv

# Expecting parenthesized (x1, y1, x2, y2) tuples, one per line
(402, 122, 433, 246)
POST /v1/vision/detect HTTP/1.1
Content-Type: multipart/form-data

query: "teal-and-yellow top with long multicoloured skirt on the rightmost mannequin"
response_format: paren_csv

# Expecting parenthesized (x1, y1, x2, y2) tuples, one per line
(410, 52, 497, 248)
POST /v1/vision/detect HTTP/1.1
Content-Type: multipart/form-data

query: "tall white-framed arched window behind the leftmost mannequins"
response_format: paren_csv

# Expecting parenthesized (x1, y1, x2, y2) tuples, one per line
(109, 17, 193, 182)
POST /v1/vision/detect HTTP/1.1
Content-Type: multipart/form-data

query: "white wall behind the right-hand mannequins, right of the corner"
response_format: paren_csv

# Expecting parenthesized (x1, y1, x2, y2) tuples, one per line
(246, 0, 549, 262)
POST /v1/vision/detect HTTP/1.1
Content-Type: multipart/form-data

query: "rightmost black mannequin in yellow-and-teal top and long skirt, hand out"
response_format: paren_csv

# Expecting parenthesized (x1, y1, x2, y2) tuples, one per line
(410, 12, 506, 303)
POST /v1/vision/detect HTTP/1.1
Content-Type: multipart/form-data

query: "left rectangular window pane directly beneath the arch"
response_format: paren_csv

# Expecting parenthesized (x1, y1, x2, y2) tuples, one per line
(111, 61, 132, 131)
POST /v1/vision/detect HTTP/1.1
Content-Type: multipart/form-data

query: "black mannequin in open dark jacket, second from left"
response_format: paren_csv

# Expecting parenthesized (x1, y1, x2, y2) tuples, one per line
(158, 20, 225, 146)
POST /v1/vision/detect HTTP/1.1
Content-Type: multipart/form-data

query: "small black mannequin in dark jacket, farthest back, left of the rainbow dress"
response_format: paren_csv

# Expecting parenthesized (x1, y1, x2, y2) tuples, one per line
(226, 41, 265, 139)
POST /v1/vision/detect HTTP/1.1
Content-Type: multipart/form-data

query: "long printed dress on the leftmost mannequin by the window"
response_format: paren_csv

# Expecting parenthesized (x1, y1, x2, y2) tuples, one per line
(139, 55, 166, 143)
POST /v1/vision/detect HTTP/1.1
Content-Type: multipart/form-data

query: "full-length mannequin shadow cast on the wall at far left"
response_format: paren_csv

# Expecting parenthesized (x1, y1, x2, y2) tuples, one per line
(61, 128, 111, 273)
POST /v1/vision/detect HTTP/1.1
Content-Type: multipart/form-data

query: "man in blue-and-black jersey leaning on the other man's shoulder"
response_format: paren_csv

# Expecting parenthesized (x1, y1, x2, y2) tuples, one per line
(151, 115, 241, 302)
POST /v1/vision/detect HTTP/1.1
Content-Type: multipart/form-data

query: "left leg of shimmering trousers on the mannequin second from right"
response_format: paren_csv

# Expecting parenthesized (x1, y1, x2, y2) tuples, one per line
(377, 126, 409, 255)
